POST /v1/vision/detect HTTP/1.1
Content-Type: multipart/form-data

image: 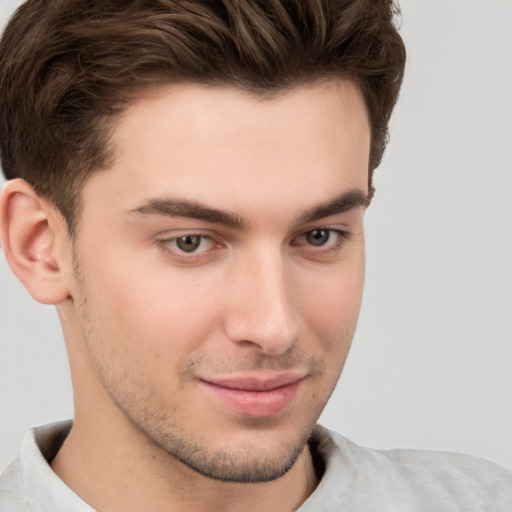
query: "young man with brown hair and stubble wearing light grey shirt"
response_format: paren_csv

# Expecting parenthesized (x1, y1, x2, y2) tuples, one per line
(0, 0, 512, 512)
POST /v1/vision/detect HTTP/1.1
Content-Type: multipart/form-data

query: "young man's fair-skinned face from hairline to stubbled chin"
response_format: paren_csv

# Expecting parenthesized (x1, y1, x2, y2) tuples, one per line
(65, 82, 370, 482)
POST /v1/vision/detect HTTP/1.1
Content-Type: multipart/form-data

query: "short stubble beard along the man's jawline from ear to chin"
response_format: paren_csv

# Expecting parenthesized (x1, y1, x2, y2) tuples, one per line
(75, 258, 350, 484)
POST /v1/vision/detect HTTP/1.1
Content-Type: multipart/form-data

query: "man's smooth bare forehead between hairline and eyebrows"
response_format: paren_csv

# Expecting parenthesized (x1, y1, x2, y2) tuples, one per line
(80, 81, 370, 223)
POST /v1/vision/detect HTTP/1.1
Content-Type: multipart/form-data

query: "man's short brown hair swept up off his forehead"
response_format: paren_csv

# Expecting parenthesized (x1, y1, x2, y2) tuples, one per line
(0, 0, 405, 233)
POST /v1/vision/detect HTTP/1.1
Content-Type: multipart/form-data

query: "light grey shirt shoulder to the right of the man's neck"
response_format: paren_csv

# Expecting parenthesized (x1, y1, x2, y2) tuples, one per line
(306, 427, 512, 512)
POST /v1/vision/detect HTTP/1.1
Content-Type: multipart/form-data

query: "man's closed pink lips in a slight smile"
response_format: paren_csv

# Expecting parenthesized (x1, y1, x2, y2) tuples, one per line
(200, 374, 305, 418)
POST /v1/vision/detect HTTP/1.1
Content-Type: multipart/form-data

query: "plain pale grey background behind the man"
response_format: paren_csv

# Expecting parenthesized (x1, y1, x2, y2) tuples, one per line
(0, 0, 512, 470)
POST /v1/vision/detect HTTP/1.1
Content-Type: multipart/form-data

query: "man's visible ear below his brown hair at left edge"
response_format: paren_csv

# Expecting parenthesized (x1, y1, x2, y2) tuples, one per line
(0, 179, 72, 304)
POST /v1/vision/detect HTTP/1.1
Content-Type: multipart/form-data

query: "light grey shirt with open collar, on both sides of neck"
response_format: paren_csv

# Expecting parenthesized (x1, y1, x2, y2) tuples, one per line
(0, 422, 512, 512)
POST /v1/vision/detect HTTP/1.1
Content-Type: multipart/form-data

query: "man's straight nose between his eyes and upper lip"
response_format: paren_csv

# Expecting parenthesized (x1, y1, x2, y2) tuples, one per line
(225, 249, 299, 356)
